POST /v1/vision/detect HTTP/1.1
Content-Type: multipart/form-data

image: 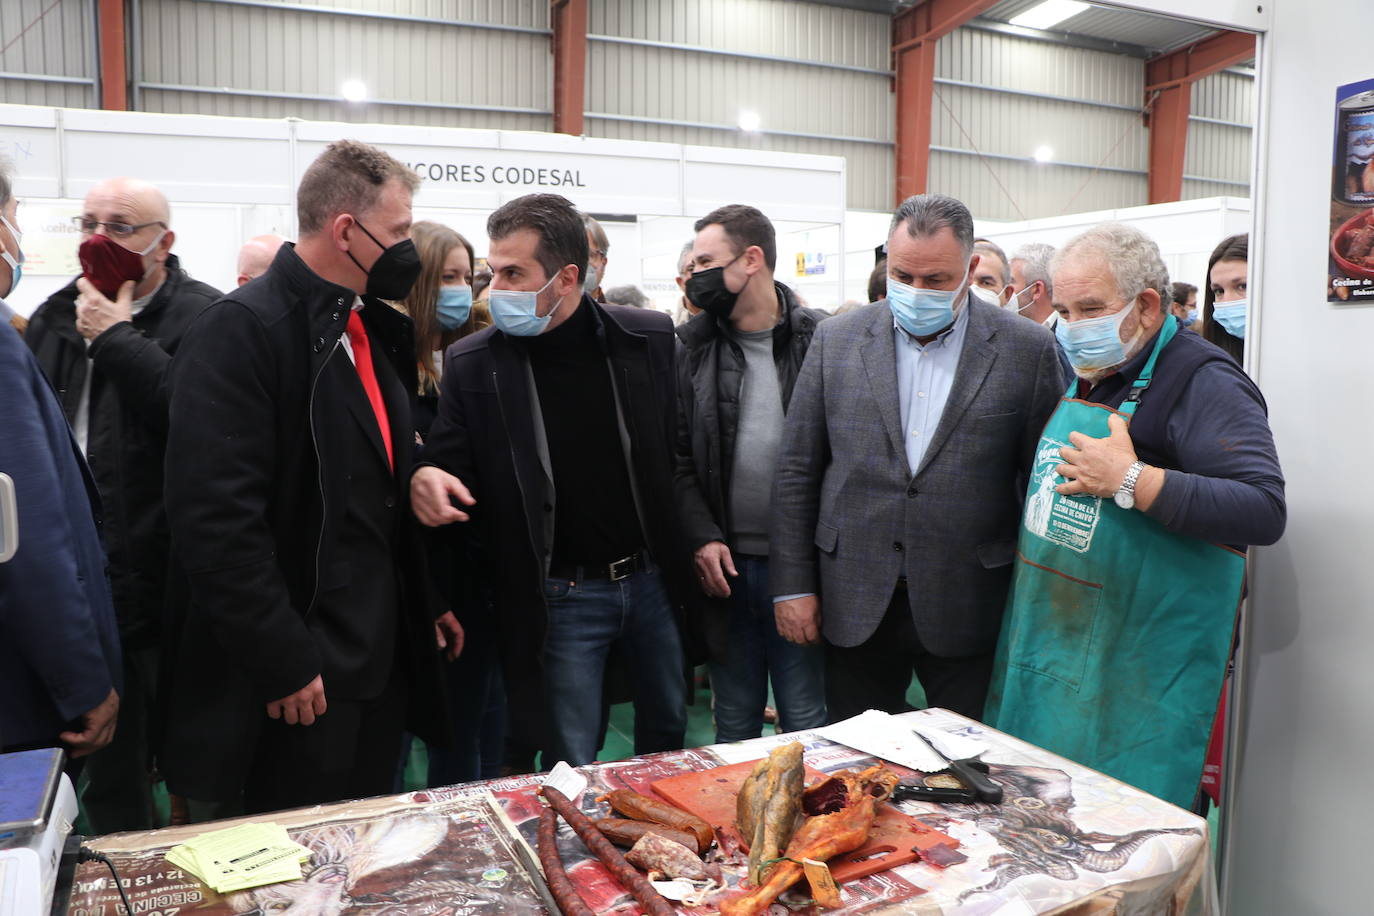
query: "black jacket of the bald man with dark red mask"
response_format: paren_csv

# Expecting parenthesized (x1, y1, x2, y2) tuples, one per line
(25, 254, 220, 651)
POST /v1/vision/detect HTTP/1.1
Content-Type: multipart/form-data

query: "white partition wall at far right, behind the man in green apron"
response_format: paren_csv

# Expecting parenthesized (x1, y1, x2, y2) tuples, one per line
(1220, 0, 1374, 916)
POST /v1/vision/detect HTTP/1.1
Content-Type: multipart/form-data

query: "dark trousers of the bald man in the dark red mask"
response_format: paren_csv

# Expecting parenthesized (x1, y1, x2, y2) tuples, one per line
(81, 648, 158, 834)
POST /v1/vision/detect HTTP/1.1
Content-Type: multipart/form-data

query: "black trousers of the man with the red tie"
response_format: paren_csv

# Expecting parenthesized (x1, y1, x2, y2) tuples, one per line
(243, 666, 407, 814)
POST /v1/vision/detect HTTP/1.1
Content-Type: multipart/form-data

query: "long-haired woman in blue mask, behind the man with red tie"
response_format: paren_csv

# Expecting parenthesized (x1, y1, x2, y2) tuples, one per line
(398, 220, 492, 442)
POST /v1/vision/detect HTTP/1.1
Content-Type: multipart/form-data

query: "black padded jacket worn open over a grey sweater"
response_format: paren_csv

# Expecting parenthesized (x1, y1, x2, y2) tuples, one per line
(673, 283, 829, 551)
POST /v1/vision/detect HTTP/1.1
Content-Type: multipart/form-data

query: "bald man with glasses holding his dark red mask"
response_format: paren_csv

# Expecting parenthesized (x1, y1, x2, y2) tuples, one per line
(25, 179, 220, 834)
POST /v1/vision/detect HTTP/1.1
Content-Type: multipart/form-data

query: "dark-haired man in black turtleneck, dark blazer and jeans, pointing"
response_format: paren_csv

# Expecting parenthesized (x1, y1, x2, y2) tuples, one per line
(411, 194, 687, 769)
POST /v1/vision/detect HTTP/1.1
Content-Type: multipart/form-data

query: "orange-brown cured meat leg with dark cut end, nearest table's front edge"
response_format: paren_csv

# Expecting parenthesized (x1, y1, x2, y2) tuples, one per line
(720, 766, 900, 916)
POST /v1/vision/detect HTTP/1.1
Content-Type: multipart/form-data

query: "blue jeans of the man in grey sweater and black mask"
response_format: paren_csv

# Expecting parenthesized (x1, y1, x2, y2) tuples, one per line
(710, 553, 826, 743)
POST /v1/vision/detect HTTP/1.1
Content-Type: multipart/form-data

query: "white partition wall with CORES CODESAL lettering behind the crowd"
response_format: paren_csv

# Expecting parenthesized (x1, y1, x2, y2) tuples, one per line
(0, 106, 845, 313)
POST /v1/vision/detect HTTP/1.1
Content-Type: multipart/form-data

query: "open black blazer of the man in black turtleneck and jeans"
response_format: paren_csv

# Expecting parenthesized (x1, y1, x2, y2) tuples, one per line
(425, 295, 690, 746)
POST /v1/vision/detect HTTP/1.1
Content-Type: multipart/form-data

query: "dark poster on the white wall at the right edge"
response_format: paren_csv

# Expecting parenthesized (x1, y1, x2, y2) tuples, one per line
(1326, 80, 1374, 304)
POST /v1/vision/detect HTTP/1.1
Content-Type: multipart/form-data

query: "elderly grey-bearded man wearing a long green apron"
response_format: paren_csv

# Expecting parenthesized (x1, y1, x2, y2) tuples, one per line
(985, 224, 1286, 808)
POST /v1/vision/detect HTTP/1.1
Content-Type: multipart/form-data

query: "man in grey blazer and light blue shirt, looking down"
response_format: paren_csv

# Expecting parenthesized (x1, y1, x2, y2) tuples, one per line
(771, 195, 1065, 721)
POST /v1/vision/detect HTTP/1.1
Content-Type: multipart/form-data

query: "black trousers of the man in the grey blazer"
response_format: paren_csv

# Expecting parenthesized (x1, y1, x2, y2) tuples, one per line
(822, 584, 993, 722)
